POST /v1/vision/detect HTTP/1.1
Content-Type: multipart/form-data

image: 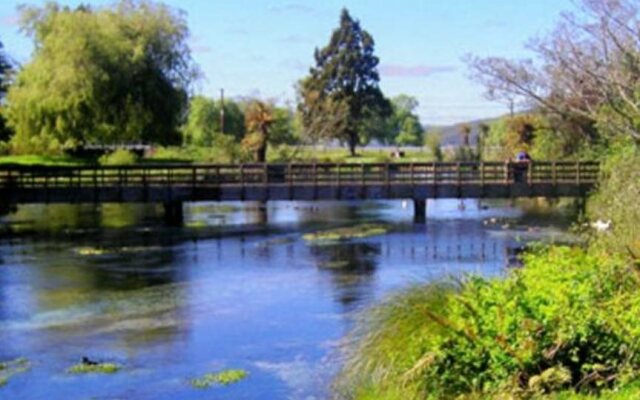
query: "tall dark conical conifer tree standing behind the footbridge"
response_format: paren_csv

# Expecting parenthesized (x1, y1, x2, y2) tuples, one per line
(299, 9, 391, 155)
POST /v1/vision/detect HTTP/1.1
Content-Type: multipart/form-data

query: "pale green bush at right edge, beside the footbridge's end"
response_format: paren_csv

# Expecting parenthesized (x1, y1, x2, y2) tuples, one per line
(587, 141, 640, 259)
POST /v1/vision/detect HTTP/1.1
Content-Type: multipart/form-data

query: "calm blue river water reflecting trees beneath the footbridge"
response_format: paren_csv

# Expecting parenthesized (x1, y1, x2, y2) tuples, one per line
(0, 201, 566, 399)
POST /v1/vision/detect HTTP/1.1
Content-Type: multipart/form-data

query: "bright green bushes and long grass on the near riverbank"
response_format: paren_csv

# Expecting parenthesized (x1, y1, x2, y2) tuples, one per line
(338, 247, 640, 399)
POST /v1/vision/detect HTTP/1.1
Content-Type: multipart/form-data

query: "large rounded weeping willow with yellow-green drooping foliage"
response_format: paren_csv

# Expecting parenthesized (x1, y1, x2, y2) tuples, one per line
(5, 0, 194, 153)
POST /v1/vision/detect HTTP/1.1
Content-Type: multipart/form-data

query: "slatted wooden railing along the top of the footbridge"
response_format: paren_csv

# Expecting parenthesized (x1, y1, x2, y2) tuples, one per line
(0, 161, 599, 189)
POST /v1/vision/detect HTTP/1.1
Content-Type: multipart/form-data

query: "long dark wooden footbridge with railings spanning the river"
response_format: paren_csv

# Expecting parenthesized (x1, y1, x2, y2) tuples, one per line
(0, 162, 599, 223)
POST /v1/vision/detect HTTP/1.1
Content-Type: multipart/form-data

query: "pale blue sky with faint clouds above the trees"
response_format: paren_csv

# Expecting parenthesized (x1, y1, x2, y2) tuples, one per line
(0, 0, 574, 125)
